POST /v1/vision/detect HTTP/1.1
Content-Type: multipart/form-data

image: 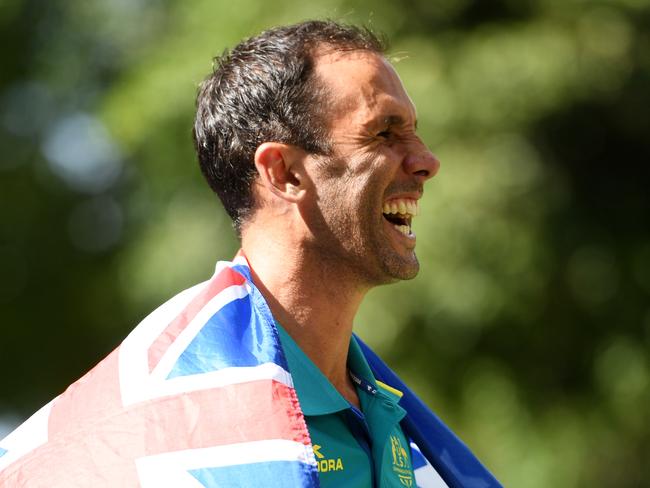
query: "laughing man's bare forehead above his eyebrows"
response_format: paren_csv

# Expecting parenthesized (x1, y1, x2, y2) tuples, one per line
(315, 51, 416, 125)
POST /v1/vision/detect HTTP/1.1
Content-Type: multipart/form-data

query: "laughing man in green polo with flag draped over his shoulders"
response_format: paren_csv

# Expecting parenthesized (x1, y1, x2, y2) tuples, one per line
(0, 22, 499, 487)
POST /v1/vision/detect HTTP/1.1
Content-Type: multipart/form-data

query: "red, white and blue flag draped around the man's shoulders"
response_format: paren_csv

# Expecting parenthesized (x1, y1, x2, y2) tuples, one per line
(0, 254, 500, 488)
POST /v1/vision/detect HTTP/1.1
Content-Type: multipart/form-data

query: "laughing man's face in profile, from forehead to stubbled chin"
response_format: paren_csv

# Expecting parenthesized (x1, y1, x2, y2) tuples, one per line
(305, 51, 440, 286)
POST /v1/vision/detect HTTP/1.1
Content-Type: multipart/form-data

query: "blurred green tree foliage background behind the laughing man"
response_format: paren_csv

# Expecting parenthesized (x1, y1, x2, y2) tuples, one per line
(0, 0, 650, 488)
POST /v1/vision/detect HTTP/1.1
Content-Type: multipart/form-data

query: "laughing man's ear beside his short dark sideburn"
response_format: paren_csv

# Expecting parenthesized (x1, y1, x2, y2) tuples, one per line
(255, 142, 306, 202)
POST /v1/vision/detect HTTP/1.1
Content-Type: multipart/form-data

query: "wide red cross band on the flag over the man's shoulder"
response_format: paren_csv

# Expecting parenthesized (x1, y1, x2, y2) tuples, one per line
(0, 380, 309, 488)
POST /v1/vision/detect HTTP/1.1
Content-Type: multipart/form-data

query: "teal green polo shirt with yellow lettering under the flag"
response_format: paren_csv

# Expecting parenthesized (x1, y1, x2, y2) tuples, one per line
(276, 323, 415, 488)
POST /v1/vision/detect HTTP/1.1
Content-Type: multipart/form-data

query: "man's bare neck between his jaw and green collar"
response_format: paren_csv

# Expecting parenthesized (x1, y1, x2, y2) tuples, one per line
(242, 227, 368, 398)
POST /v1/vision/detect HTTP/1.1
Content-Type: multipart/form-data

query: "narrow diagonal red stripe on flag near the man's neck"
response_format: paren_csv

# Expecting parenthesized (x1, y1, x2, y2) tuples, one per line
(149, 268, 246, 373)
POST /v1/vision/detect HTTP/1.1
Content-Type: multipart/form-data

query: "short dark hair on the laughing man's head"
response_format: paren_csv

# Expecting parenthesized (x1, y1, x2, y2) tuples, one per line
(193, 20, 386, 234)
